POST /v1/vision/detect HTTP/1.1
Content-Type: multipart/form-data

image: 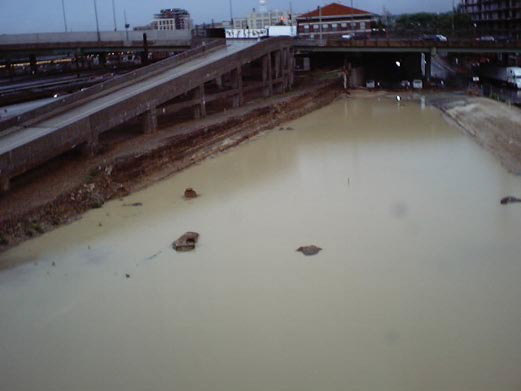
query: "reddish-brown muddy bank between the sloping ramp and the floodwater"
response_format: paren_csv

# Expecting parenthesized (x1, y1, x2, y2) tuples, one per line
(0, 81, 342, 252)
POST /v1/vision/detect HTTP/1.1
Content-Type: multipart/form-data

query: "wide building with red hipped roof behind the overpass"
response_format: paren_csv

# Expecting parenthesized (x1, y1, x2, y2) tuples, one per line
(297, 3, 378, 39)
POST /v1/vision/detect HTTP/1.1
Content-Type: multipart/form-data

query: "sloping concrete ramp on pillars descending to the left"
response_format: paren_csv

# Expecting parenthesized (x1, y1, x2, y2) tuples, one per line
(0, 38, 294, 191)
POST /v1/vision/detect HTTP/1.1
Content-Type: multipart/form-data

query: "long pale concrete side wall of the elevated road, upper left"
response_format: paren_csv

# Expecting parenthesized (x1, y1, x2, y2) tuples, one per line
(0, 30, 192, 45)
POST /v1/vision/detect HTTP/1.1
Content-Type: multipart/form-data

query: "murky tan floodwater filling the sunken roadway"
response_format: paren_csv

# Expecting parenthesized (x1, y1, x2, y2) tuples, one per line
(0, 97, 521, 391)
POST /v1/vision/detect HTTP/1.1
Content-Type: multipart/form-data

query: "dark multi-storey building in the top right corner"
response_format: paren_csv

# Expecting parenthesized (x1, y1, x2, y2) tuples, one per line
(460, 0, 521, 38)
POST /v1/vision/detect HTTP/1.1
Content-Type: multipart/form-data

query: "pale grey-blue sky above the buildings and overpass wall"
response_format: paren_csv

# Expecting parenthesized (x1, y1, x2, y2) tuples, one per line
(0, 0, 457, 34)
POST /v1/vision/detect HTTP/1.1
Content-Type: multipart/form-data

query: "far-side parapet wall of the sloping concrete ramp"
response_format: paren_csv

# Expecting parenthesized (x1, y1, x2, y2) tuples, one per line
(0, 39, 226, 132)
